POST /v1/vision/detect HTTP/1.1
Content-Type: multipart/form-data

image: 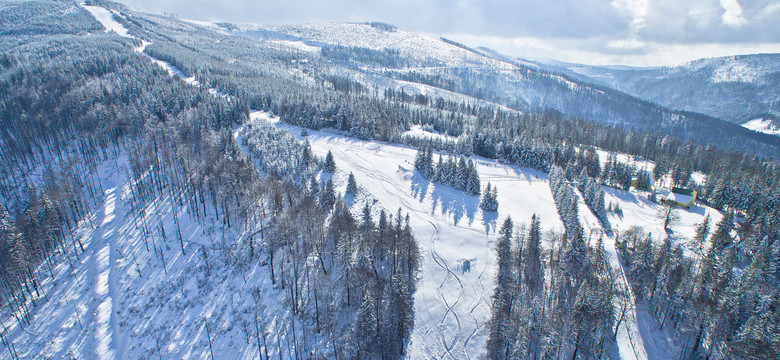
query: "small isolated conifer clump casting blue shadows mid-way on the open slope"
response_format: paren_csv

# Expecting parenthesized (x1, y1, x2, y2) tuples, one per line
(414, 148, 481, 195)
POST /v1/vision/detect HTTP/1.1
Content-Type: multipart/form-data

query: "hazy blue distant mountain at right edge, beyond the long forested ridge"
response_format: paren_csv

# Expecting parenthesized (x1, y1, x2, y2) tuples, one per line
(539, 54, 780, 127)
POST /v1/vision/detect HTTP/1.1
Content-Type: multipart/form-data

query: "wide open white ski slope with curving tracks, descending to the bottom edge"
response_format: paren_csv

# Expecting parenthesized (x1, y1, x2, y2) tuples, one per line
(252, 112, 563, 359)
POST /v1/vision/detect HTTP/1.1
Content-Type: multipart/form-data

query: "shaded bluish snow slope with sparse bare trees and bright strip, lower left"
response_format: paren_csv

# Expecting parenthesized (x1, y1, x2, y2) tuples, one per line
(3, 156, 328, 359)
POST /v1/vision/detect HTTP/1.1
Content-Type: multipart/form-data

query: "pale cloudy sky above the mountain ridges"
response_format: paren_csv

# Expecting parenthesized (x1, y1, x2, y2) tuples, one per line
(125, 0, 780, 66)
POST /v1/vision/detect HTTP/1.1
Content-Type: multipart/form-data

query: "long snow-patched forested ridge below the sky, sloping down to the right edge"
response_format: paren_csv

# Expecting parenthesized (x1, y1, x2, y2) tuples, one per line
(218, 23, 780, 155)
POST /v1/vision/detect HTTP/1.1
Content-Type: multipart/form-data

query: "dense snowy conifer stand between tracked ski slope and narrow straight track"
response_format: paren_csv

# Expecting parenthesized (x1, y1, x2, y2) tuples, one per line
(487, 215, 621, 359)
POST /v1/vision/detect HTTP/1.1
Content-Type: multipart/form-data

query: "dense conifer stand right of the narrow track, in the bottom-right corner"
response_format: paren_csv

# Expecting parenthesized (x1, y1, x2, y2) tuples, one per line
(621, 225, 780, 359)
